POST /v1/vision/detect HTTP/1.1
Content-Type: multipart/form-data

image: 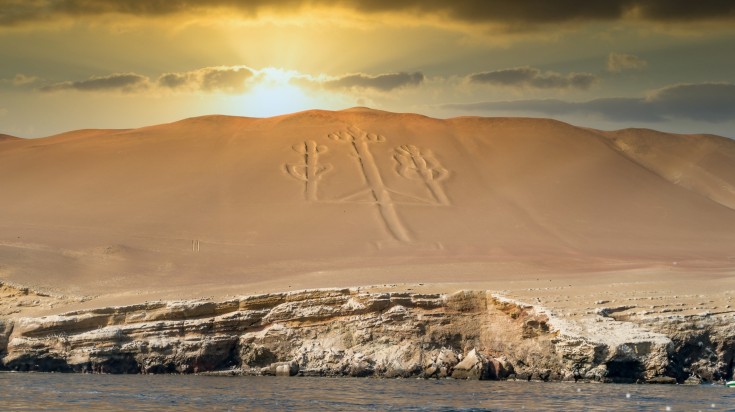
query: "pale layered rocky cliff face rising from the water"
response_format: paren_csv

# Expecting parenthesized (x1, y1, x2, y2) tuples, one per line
(0, 289, 735, 382)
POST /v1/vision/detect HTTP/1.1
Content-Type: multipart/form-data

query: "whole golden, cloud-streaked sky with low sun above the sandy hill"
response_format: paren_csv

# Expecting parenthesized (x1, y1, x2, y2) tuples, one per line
(0, 0, 735, 138)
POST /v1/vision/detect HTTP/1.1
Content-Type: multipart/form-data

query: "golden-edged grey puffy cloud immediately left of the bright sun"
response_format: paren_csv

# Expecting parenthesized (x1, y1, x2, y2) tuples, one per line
(158, 66, 255, 93)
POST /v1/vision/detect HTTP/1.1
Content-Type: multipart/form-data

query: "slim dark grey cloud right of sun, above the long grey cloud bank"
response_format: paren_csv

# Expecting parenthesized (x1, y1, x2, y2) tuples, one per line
(468, 67, 598, 90)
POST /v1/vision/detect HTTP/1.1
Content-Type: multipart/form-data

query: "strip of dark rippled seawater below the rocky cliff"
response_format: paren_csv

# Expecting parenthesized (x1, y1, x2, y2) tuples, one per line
(0, 373, 735, 411)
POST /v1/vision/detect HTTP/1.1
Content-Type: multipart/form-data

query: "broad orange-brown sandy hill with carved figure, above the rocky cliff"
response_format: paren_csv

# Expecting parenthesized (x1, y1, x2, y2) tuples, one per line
(0, 108, 735, 312)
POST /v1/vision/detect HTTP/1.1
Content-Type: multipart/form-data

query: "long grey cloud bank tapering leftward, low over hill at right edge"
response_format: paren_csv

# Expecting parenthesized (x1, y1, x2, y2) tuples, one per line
(442, 83, 735, 123)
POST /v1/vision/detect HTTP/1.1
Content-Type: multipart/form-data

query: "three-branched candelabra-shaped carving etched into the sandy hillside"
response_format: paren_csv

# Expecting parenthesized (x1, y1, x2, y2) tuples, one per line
(286, 127, 451, 242)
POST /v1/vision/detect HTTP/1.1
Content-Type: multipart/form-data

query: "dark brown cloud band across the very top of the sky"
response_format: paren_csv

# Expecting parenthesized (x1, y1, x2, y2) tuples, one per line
(0, 0, 735, 26)
